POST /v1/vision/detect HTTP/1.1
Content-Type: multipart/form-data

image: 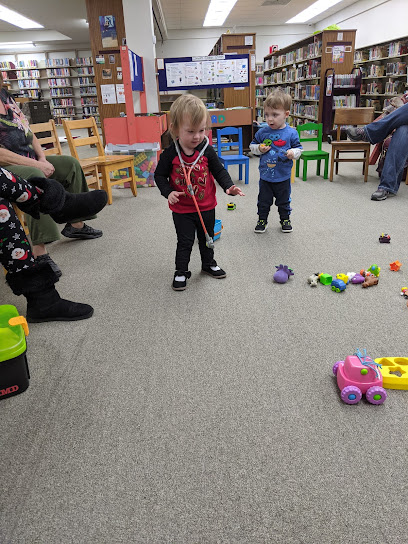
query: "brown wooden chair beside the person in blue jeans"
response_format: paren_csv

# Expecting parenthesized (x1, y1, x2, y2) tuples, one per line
(330, 108, 374, 182)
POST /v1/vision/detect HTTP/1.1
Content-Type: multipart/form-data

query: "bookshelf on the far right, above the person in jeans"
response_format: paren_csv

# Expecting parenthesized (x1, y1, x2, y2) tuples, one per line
(354, 37, 408, 116)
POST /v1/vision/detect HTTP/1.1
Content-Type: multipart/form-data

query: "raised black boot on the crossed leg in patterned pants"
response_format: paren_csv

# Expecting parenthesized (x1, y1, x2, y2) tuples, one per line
(30, 178, 108, 223)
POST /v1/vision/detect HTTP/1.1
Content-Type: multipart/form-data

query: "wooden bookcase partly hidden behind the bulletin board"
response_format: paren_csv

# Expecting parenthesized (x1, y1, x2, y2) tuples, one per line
(209, 34, 256, 119)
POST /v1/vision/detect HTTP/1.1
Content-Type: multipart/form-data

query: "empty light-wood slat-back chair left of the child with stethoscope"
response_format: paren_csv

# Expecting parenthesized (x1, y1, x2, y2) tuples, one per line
(62, 117, 137, 204)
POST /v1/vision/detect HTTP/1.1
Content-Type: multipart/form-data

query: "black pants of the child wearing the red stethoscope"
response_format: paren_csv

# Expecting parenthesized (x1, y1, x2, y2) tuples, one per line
(173, 209, 217, 272)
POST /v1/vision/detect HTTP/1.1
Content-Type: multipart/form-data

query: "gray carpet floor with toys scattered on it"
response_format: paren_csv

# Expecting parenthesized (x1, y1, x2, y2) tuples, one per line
(0, 141, 408, 544)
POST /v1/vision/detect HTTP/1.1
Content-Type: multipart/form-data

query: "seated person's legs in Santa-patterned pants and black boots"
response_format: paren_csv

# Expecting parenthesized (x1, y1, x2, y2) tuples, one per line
(0, 168, 107, 323)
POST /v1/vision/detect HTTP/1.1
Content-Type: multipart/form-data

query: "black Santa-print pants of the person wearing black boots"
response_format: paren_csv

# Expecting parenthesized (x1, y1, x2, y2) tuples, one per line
(0, 168, 41, 274)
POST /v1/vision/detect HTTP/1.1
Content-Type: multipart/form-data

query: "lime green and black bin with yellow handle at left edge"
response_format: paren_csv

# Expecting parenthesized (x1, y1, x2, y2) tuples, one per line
(0, 304, 30, 400)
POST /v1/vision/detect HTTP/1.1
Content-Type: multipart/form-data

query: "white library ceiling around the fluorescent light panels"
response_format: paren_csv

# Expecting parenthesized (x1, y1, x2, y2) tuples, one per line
(0, 0, 356, 54)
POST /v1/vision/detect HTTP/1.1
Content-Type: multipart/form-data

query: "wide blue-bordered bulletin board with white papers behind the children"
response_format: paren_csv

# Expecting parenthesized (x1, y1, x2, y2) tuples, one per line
(157, 54, 251, 91)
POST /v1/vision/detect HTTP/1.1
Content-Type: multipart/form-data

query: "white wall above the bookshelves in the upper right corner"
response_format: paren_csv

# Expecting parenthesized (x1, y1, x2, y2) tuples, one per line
(315, 0, 408, 49)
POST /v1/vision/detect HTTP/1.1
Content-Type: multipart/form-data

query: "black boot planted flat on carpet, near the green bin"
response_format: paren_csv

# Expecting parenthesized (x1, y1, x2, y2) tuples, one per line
(6, 263, 93, 323)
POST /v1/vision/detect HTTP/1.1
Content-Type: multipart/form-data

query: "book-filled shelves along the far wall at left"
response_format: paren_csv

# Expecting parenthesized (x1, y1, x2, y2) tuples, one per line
(0, 57, 99, 125)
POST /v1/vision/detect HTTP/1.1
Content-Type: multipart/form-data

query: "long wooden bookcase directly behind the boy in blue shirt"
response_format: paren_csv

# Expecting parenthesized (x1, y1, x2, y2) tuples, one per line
(264, 30, 356, 130)
